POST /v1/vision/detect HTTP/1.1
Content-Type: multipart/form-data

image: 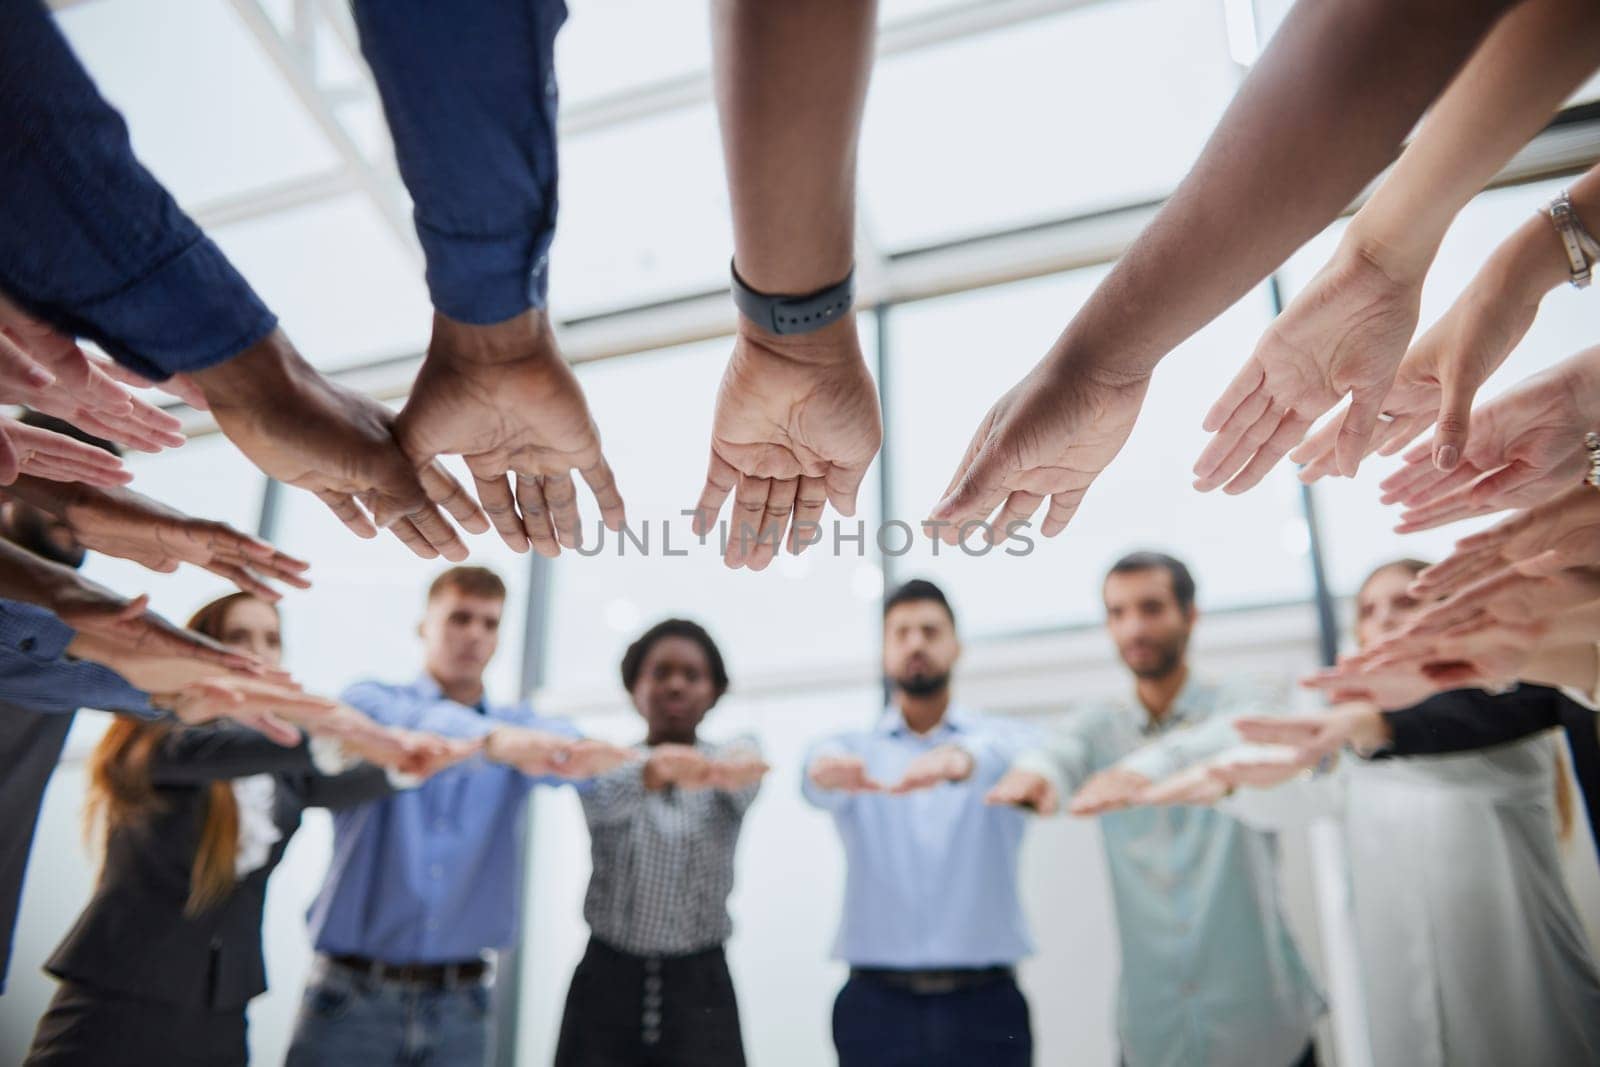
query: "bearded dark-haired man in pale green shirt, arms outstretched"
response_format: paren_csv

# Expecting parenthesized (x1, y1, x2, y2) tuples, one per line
(990, 552, 1325, 1067)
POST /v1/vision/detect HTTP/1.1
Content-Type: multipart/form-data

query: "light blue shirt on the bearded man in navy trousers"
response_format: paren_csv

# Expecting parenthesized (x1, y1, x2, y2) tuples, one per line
(802, 705, 1037, 969)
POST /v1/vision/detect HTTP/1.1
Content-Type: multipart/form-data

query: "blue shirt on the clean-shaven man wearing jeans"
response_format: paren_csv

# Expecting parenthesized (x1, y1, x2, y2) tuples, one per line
(309, 675, 576, 965)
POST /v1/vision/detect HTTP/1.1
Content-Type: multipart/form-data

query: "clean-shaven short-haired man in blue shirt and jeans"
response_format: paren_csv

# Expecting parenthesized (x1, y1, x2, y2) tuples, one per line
(288, 566, 634, 1067)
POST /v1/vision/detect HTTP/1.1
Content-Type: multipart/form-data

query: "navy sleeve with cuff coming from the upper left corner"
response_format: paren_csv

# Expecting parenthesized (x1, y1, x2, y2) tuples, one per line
(0, 0, 277, 379)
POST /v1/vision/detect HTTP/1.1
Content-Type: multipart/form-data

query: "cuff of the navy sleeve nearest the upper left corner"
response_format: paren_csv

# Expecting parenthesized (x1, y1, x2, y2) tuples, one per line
(72, 237, 278, 381)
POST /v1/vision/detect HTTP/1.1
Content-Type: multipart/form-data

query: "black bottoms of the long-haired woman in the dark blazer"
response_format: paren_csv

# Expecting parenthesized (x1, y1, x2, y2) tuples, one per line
(24, 982, 250, 1067)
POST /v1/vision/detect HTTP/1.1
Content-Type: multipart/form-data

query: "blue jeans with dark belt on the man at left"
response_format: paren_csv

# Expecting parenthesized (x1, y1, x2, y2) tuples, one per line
(283, 957, 490, 1067)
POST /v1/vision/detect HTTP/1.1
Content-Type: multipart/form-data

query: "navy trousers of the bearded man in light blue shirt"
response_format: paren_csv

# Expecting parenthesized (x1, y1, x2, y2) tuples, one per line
(834, 974, 1034, 1067)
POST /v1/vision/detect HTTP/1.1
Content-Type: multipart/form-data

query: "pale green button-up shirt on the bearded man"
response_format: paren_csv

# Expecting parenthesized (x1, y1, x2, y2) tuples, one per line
(1016, 680, 1326, 1067)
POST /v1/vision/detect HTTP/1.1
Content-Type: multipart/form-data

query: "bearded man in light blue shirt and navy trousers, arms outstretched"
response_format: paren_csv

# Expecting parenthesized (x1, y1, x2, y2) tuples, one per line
(803, 581, 1032, 1067)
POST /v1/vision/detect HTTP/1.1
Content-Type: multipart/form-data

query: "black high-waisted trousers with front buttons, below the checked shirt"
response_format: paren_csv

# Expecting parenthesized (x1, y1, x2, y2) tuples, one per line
(555, 939, 744, 1067)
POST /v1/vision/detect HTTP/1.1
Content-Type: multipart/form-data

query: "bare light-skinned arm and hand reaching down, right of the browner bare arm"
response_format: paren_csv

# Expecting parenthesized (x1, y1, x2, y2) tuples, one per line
(1195, 0, 1600, 493)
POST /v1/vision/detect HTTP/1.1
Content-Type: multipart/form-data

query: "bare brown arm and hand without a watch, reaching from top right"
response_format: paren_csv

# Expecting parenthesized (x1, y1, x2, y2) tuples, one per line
(930, 0, 1512, 544)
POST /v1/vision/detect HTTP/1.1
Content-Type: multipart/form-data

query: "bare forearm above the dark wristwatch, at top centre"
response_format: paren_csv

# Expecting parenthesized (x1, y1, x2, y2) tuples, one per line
(712, 0, 877, 293)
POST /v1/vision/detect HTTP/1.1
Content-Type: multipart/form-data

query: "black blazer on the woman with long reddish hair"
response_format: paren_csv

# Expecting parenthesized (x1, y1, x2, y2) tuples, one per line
(45, 726, 389, 1011)
